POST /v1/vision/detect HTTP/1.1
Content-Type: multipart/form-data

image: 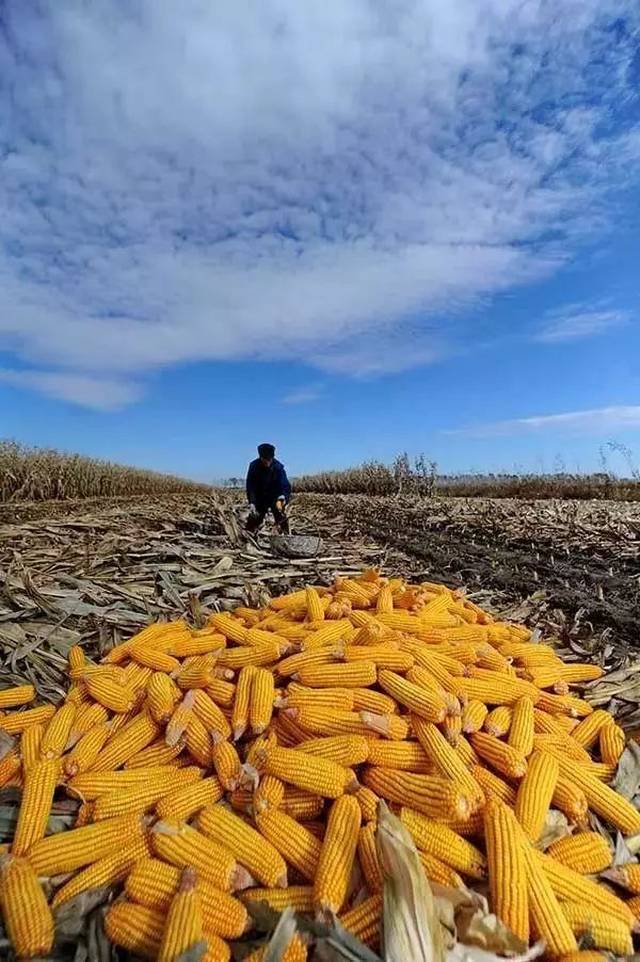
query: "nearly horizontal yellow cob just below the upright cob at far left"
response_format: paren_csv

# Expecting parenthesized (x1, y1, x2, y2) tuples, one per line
(29, 814, 145, 876)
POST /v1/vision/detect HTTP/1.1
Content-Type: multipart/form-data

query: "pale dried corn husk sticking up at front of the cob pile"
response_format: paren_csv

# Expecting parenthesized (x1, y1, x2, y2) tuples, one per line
(376, 802, 446, 962)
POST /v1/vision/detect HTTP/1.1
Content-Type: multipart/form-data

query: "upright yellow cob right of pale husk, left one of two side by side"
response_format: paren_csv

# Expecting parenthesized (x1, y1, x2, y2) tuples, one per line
(484, 798, 529, 944)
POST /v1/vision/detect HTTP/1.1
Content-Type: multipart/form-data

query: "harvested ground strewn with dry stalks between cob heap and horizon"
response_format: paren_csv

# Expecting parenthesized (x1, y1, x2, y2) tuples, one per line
(0, 491, 640, 698)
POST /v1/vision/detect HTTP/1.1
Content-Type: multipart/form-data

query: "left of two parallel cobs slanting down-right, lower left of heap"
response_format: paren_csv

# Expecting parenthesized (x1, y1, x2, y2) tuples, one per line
(151, 819, 242, 892)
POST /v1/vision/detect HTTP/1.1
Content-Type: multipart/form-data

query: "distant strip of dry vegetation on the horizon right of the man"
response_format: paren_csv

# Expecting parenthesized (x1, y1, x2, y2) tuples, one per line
(293, 454, 640, 501)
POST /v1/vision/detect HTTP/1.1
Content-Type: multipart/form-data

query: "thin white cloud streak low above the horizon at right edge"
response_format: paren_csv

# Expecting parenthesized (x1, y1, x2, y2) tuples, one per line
(443, 404, 640, 438)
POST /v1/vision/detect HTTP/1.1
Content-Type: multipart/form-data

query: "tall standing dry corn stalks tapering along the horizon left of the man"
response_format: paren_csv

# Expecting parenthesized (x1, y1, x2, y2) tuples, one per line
(0, 441, 208, 503)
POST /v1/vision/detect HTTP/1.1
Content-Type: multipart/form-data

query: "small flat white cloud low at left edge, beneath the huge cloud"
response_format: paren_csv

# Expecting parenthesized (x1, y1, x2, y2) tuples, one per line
(0, 368, 141, 411)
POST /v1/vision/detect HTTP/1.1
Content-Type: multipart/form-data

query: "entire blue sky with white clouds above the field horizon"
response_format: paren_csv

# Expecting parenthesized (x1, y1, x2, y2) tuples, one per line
(0, 0, 640, 478)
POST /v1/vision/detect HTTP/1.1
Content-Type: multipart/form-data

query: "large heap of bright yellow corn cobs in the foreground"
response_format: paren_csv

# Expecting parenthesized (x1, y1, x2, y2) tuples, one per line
(0, 571, 640, 962)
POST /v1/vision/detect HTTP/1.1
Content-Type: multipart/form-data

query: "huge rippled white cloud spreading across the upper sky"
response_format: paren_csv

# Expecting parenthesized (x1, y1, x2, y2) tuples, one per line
(0, 0, 640, 397)
